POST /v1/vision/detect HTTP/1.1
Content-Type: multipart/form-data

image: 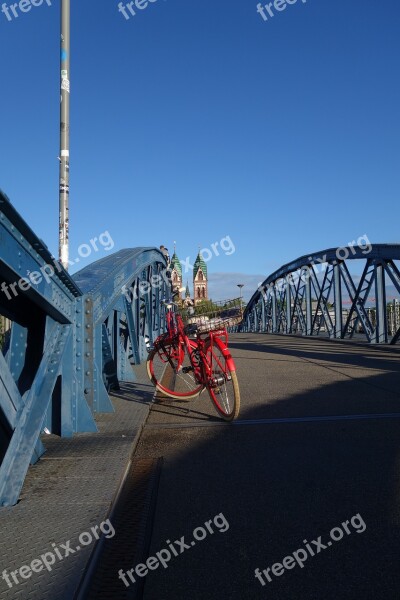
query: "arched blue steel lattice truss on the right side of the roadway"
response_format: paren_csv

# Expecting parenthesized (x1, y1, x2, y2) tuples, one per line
(240, 244, 400, 344)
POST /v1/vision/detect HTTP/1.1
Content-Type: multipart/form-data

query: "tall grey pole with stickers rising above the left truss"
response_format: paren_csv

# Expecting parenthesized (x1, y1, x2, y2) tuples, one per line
(58, 0, 71, 269)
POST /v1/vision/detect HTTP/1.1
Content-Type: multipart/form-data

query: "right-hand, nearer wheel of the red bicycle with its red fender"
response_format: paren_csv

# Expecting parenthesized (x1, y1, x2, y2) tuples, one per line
(205, 338, 240, 421)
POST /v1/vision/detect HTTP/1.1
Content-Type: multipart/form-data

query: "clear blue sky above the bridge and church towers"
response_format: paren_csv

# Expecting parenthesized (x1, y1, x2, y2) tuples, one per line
(0, 0, 400, 297)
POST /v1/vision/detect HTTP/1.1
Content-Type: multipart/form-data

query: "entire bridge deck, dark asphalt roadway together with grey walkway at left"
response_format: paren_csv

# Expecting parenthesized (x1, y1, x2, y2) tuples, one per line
(0, 334, 400, 600)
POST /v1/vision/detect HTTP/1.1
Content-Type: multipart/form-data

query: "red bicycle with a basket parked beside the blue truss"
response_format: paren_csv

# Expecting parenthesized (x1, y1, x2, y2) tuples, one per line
(147, 303, 240, 421)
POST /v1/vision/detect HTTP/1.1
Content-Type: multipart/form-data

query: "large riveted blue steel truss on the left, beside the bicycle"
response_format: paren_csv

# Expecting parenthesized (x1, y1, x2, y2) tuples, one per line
(0, 192, 170, 506)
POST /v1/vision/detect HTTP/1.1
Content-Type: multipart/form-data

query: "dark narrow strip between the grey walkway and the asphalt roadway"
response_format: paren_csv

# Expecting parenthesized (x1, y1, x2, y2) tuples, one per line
(77, 458, 162, 600)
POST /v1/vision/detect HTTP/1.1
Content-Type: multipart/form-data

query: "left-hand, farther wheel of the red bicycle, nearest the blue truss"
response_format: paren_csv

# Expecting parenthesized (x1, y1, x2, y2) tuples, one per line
(146, 341, 204, 400)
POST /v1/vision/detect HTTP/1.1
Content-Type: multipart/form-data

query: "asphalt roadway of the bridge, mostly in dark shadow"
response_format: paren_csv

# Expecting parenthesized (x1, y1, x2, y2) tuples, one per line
(135, 334, 400, 600)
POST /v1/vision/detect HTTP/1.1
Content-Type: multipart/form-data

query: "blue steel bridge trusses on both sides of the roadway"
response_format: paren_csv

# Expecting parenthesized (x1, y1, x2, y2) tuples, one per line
(0, 186, 400, 506)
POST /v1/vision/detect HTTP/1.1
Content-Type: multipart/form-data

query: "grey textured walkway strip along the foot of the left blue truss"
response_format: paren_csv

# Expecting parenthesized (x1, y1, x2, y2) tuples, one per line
(0, 366, 154, 600)
